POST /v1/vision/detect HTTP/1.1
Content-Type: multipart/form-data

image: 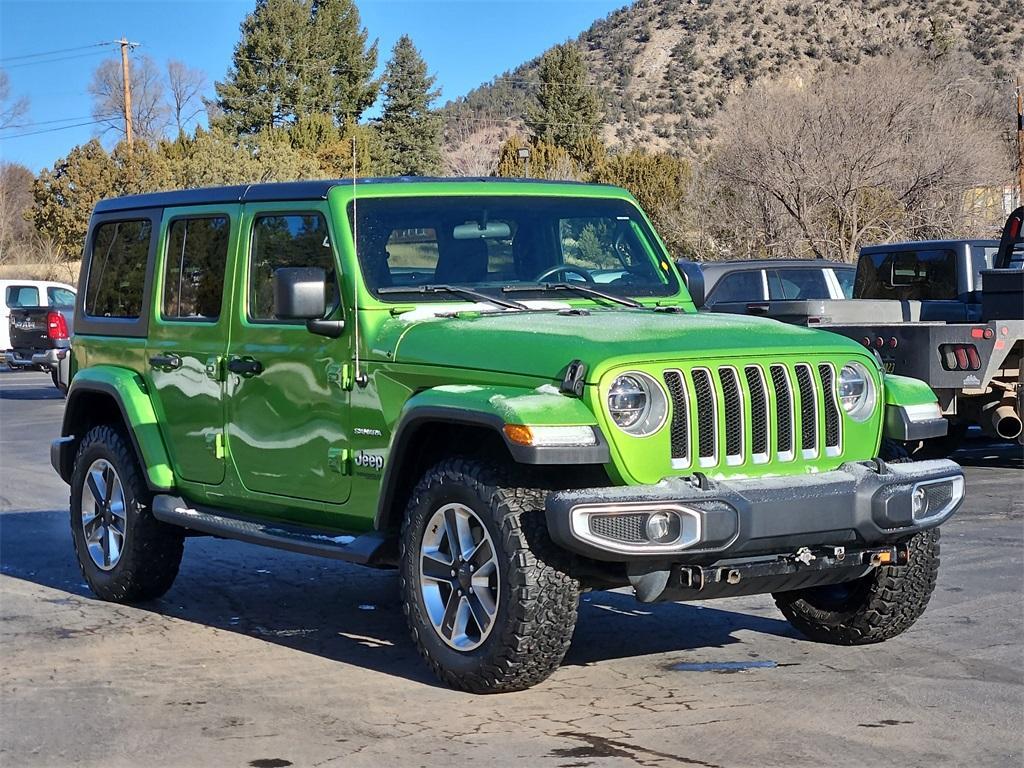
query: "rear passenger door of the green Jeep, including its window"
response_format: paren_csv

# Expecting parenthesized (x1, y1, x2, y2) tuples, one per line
(145, 206, 234, 485)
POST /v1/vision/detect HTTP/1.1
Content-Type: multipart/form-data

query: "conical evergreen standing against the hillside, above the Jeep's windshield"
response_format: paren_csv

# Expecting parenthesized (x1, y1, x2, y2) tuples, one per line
(526, 43, 601, 160)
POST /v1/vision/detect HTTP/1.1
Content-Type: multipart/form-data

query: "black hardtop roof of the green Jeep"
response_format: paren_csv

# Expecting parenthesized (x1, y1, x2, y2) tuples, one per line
(95, 176, 607, 213)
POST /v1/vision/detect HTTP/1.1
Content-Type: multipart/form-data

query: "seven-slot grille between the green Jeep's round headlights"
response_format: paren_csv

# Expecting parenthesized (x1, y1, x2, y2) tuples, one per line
(664, 362, 842, 469)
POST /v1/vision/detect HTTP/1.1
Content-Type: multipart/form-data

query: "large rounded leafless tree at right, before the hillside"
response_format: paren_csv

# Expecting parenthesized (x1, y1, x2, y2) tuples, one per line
(709, 57, 1009, 260)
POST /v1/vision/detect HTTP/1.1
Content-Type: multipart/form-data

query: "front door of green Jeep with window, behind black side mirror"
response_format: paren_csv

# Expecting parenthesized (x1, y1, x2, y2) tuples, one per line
(226, 203, 351, 504)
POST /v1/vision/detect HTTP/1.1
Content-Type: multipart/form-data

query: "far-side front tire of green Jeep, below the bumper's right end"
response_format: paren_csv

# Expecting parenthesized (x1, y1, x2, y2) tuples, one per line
(772, 528, 939, 645)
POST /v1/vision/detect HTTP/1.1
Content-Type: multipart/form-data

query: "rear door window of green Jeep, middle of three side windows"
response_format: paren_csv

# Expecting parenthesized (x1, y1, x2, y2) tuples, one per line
(161, 216, 231, 323)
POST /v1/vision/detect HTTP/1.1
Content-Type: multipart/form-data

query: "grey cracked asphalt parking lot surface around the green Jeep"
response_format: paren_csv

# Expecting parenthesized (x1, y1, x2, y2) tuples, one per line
(0, 372, 1024, 768)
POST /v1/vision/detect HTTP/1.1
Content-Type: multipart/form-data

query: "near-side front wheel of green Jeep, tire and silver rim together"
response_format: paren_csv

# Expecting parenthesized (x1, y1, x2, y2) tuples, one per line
(399, 459, 580, 693)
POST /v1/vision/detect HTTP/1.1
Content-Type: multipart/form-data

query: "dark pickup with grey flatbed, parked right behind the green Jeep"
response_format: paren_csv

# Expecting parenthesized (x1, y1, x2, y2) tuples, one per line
(680, 222, 1024, 454)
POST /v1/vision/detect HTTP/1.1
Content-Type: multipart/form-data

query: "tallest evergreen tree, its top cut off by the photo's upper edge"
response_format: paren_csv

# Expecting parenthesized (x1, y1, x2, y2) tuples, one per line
(214, 0, 379, 134)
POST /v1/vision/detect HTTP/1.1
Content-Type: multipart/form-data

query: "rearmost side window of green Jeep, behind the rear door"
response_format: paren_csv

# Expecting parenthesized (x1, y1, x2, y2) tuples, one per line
(85, 219, 153, 319)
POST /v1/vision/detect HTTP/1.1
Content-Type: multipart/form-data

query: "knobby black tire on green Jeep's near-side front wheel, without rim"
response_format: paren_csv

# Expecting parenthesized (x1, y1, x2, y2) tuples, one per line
(399, 459, 580, 693)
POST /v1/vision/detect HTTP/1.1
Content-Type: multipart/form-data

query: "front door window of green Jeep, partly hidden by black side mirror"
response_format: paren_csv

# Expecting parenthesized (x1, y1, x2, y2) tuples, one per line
(249, 213, 338, 322)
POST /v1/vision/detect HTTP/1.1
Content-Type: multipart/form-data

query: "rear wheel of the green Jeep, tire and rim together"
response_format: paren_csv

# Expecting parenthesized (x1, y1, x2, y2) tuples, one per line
(71, 426, 184, 603)
